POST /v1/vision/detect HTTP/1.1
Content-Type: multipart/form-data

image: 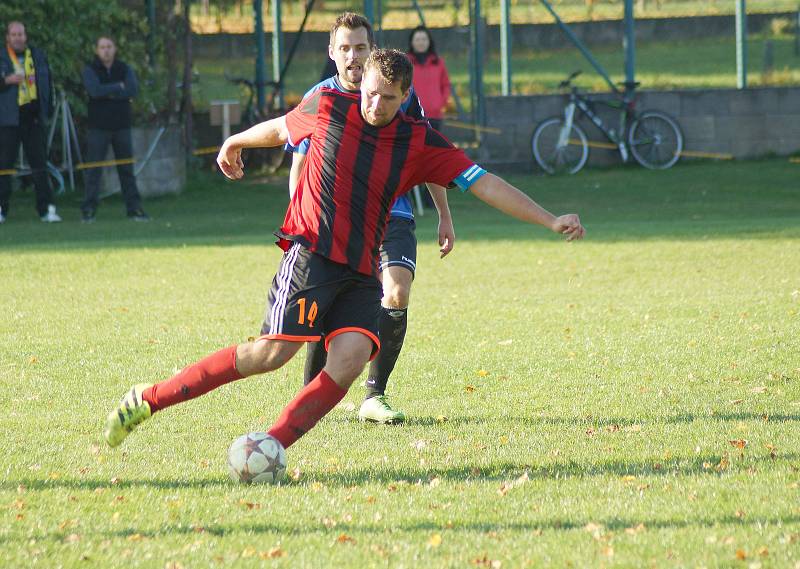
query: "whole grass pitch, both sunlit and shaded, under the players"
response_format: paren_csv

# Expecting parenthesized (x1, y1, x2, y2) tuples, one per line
(0, 160, 800, 569)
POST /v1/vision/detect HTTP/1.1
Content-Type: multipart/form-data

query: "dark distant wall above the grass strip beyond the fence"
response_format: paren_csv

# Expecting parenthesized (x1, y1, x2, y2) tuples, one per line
(193, 12, 797, 57)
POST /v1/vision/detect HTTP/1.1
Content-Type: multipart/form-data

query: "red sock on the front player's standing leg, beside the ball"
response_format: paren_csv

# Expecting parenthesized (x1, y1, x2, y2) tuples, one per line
(269, 370, 347, 448)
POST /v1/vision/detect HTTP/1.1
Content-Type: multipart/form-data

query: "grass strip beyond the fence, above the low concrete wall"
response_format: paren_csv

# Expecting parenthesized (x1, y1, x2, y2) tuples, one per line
(194, 35, 800, 112)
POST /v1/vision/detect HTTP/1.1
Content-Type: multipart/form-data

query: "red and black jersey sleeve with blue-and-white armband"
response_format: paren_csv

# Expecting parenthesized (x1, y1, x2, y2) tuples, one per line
(417, 127, 486, 191)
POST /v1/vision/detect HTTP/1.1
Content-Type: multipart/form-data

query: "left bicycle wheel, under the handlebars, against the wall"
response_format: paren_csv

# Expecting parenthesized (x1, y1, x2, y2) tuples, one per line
(531, 117, 589, 174)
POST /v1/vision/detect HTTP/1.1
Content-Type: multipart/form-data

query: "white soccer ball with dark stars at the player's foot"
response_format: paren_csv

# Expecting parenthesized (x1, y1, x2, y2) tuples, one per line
(228, 433, 286, 484)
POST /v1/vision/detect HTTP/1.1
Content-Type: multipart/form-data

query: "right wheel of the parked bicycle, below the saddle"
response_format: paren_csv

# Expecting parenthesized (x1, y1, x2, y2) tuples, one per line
(628, 111, 683, 170)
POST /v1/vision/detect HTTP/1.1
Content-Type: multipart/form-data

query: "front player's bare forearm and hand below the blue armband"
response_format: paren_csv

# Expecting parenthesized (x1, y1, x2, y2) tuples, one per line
(469, 173, 586, 241)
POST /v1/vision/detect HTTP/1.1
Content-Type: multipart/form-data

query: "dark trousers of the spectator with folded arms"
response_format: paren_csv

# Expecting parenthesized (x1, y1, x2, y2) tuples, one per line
(81, 128, 142, 213)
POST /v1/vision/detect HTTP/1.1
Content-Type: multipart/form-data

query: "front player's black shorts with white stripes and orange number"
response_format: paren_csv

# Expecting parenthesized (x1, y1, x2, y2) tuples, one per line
(261, 243, 382, 356)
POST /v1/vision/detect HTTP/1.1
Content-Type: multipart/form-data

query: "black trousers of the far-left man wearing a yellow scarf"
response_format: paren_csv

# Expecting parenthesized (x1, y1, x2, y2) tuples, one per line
(0, 113, 53, 217)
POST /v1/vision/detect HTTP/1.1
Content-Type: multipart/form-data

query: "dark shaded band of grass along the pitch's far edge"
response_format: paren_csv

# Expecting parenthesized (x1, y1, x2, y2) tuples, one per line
(0, 159, 800, 251)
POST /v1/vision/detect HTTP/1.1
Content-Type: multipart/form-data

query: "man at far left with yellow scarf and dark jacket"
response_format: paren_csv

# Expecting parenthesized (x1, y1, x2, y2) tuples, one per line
(0, 22, 61, 223)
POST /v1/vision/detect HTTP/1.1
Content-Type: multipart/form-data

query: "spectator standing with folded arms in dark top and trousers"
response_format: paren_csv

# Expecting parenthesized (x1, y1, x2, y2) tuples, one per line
(81, 36, 150, 223)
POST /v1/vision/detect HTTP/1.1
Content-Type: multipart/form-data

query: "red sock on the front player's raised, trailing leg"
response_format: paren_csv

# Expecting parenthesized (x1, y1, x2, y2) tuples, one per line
(142, 346, 242, 413)
